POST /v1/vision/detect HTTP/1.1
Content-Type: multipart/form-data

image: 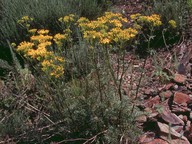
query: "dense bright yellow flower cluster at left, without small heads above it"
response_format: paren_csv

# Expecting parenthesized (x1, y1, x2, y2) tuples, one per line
(17, 29, 64, 78)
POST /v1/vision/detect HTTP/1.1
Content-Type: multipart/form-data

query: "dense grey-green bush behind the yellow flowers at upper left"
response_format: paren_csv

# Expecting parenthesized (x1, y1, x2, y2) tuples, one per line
(0, 0, 109, 44)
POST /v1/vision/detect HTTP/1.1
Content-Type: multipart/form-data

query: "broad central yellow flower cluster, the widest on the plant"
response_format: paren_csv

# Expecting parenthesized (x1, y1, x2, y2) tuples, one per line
(77, 12, 138, 44)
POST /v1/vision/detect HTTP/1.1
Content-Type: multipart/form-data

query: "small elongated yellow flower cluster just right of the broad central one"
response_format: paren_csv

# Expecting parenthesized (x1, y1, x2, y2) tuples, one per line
(130, 14, 162, 27)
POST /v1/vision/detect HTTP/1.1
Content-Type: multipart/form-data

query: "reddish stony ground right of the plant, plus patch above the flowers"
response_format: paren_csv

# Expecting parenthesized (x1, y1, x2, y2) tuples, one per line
(114, 0, 192, 144)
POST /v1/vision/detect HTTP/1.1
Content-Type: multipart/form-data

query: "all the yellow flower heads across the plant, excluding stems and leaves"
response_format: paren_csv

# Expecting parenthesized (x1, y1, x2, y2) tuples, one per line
(14, 12, 176, 78)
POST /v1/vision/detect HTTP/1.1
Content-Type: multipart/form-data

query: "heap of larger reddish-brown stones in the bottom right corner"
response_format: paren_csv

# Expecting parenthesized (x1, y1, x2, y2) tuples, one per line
(137, 74, 192, 144)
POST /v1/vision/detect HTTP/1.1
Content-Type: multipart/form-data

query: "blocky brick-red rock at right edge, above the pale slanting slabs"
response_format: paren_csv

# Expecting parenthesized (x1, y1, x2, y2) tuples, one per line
(173, 92, 191, 104)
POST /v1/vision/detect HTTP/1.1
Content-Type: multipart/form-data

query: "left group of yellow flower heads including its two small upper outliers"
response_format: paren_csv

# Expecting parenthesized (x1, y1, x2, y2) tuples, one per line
(17, 15, 74, 78)
